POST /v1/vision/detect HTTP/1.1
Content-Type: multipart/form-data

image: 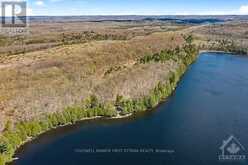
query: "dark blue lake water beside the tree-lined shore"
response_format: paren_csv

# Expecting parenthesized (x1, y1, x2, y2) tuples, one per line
(14, 53, 248, 165)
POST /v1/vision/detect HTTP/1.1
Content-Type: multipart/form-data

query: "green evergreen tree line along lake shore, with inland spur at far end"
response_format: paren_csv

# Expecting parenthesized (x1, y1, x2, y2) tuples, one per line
(0, 36, 198, 165)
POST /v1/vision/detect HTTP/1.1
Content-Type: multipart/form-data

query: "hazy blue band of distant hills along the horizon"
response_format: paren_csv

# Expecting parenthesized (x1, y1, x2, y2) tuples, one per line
(0, 15, 248, 24)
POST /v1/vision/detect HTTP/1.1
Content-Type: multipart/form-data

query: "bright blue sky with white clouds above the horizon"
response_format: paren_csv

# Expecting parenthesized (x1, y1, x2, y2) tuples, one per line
(0, 0, 248, 16)
